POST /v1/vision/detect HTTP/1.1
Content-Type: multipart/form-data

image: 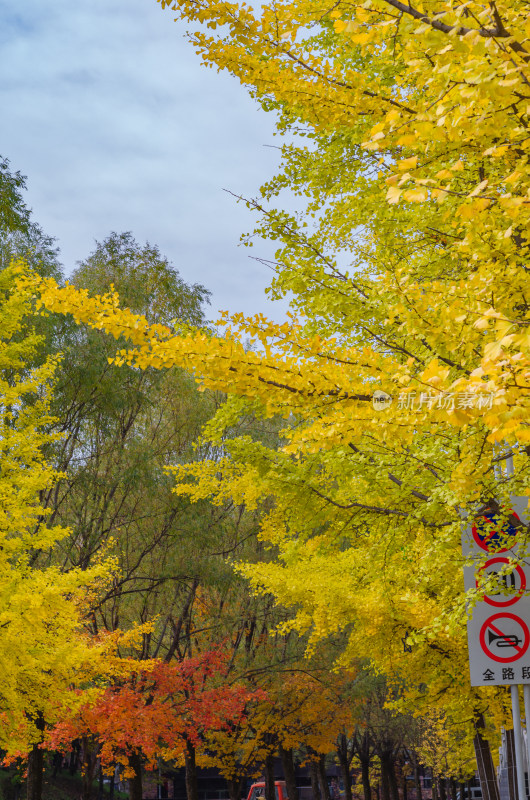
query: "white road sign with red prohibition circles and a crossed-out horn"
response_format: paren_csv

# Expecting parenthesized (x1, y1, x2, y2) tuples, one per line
(462, 497, 530, 686)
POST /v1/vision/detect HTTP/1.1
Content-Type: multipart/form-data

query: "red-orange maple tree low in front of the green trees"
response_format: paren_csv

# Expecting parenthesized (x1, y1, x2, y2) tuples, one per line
(47, 649, 263, 797)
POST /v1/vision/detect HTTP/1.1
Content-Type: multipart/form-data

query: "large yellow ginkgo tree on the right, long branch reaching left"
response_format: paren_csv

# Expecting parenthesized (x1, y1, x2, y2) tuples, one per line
(26, 0, 530, 788)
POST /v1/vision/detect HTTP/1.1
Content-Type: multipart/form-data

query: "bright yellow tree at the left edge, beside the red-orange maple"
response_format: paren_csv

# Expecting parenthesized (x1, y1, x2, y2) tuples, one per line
(0, 268, 124, 800)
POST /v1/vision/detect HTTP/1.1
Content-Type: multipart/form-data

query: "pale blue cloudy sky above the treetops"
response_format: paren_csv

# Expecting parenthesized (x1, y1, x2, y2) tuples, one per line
(0, 0, 285, 320)
